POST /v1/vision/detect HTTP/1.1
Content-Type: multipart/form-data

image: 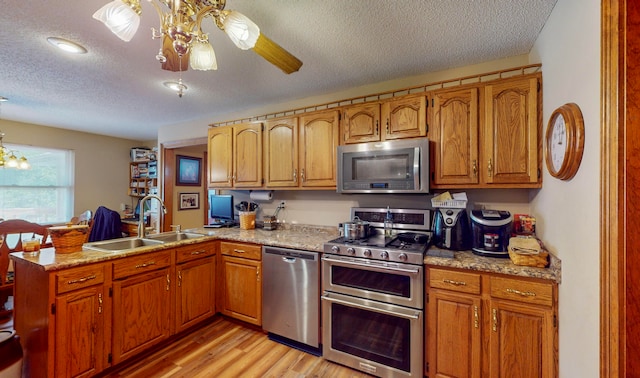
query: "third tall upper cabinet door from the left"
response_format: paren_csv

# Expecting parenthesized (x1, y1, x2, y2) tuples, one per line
(264, 118, 299, 188)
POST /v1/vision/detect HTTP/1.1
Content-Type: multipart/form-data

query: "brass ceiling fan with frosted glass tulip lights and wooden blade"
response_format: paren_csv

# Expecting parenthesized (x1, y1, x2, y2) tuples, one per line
(93, 0, 302, 74)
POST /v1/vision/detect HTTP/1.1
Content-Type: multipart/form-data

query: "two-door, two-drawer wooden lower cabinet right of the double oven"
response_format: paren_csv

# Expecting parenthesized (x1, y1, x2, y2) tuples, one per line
(425, 267, 558, 378)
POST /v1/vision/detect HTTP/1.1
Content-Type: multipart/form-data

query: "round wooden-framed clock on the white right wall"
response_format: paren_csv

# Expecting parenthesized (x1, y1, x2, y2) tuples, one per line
(546, 103, 584, 180)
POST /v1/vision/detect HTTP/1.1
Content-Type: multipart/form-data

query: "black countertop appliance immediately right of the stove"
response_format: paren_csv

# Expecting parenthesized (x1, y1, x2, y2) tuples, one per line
(433, 207, 470, 251)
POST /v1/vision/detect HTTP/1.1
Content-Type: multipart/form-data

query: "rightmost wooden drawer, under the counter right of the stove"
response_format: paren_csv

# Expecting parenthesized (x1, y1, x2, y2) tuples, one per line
(491, 277, 553, 306)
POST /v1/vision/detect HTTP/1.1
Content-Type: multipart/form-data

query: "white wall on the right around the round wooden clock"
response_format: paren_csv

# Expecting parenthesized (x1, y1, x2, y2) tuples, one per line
(531, 0, 600, 377)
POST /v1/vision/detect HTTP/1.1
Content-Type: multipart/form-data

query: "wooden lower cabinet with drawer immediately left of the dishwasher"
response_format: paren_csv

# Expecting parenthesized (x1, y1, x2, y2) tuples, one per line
(220, 242, 262, 326)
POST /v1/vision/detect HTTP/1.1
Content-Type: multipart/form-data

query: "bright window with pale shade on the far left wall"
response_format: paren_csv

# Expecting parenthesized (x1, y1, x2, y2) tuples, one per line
(0, 144, 74, 224)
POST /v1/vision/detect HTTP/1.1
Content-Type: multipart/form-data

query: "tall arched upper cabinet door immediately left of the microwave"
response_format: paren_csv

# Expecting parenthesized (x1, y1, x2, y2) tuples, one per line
(299, 110, 340, 188)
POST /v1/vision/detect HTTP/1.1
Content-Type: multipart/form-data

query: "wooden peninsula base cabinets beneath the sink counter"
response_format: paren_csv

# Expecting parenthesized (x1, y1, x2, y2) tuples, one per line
(14, 242, 218, 378)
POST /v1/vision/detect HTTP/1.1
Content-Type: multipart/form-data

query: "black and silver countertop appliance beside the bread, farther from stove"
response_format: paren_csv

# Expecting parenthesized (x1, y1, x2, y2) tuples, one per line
(471, 210, 513, 257)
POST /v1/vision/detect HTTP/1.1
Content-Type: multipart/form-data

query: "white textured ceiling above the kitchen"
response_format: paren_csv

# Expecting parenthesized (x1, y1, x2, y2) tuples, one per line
(0, 0, 557, 140)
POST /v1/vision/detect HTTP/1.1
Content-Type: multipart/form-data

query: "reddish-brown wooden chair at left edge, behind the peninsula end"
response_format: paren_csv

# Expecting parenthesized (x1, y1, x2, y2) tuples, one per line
(0, 219, 49, 317)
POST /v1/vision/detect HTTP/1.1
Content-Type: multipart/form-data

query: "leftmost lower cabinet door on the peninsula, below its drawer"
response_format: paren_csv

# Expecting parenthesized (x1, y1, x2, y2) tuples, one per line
(54, 285, 110, 377)
